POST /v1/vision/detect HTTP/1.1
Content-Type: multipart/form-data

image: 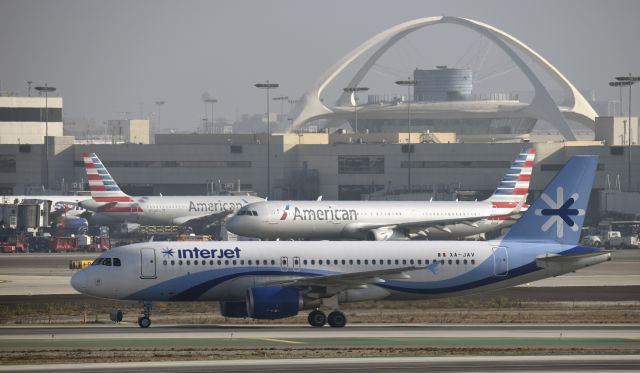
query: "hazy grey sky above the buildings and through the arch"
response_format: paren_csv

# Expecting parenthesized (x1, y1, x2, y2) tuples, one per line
(0, 0, 640, 129)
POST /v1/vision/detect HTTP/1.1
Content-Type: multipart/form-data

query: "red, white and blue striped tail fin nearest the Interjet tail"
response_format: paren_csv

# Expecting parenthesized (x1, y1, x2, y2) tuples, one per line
(489, 147, 536, 209)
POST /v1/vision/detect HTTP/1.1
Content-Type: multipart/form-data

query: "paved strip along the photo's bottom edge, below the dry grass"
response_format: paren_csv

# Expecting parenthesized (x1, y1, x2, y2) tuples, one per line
(0, 355, 640, 373)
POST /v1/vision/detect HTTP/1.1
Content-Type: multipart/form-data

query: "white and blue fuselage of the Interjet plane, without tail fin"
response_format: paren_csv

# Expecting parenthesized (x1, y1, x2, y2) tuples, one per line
(72, 241, 610, 302)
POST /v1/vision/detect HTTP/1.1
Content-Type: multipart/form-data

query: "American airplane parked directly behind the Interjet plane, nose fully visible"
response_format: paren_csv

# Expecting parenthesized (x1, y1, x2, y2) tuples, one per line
(226, 148, 536, 241)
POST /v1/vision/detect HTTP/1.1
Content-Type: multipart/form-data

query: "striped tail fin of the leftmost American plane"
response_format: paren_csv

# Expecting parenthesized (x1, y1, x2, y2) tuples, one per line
(82, 153, 133, 203)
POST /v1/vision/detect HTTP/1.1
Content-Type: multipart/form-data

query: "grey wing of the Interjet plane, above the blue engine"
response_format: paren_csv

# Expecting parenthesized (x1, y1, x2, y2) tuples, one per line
(270, 266, 424, 297)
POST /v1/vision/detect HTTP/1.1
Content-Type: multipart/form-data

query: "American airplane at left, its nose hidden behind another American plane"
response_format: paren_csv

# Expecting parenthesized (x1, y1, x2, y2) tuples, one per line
(80, 153, 263, 225)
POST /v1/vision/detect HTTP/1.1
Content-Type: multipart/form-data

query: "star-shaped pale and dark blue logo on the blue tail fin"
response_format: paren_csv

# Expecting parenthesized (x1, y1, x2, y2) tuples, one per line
(535, 187, 584, 238)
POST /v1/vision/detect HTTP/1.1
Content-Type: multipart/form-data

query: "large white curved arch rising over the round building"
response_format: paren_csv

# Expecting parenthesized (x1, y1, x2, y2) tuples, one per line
(291, 16, 597, 140)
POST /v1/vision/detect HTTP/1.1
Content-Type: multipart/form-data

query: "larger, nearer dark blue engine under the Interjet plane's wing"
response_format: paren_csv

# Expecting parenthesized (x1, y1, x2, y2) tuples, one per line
(247, 286, 303, 320)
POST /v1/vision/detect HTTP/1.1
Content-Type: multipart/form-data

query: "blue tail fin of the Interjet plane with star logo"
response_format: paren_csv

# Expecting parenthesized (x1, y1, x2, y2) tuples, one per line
(504, 155, 598, 244)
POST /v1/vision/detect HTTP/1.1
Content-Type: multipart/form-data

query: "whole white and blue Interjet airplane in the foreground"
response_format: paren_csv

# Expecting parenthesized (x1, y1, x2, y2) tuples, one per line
(71, 156, 611, 328)
